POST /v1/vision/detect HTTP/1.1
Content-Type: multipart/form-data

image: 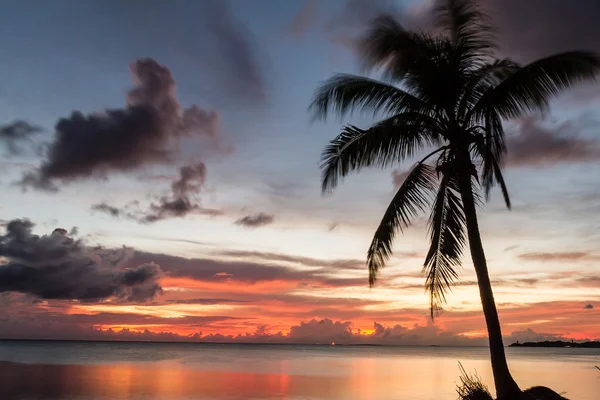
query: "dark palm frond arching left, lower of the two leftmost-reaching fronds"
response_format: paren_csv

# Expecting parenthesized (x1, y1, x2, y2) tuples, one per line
(321, 113, 436, 193)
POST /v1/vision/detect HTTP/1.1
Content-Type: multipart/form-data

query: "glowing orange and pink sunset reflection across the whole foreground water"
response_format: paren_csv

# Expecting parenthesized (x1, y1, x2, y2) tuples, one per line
(0, 355, 600, 400)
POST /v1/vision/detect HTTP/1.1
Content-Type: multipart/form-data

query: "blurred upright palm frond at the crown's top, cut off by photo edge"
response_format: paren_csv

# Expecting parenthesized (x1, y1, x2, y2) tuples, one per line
(435, 0, 497, 58)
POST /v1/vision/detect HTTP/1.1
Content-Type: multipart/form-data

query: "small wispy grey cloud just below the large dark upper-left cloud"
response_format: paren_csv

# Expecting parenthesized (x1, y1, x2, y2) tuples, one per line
(92, 162, 222, 224)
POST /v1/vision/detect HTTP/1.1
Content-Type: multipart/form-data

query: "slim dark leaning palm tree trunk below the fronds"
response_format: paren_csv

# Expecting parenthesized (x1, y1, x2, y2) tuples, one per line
(459, 167, 521, 400)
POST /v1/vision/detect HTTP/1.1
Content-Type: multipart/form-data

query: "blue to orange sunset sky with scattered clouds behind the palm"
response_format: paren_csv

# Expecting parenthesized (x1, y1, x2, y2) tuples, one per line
(0, 0, 600, 345)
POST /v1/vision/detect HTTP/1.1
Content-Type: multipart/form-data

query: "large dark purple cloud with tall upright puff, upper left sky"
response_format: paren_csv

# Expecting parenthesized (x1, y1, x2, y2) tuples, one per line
(22, 58, 225, 190)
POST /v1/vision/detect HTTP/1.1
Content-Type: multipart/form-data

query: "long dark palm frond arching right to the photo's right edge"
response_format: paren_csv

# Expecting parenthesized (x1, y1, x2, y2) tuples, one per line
(473, 51, 600, 119)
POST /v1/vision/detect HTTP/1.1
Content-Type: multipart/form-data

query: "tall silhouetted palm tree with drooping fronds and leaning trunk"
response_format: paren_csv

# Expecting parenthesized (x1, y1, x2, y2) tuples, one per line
(309, 0, 600, 399)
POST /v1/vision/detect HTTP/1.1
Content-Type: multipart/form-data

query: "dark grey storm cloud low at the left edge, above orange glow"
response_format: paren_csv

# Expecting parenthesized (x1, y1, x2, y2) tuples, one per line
(0, 220, 162, 302)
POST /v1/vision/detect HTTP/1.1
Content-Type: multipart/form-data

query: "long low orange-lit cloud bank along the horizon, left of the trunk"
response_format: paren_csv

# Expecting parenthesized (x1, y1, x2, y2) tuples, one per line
(0, 313, 485, 346)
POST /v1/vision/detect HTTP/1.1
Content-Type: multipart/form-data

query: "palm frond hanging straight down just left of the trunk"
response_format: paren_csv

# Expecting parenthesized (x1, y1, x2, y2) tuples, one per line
(423, 165, 465, 318)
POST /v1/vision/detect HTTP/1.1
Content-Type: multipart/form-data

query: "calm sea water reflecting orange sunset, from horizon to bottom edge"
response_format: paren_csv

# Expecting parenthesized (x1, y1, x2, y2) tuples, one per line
(0, 341, 600, 400)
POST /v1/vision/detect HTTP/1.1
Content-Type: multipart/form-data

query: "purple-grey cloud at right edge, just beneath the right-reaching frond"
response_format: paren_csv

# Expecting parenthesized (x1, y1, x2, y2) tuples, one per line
(507, 116, 600, 167)
